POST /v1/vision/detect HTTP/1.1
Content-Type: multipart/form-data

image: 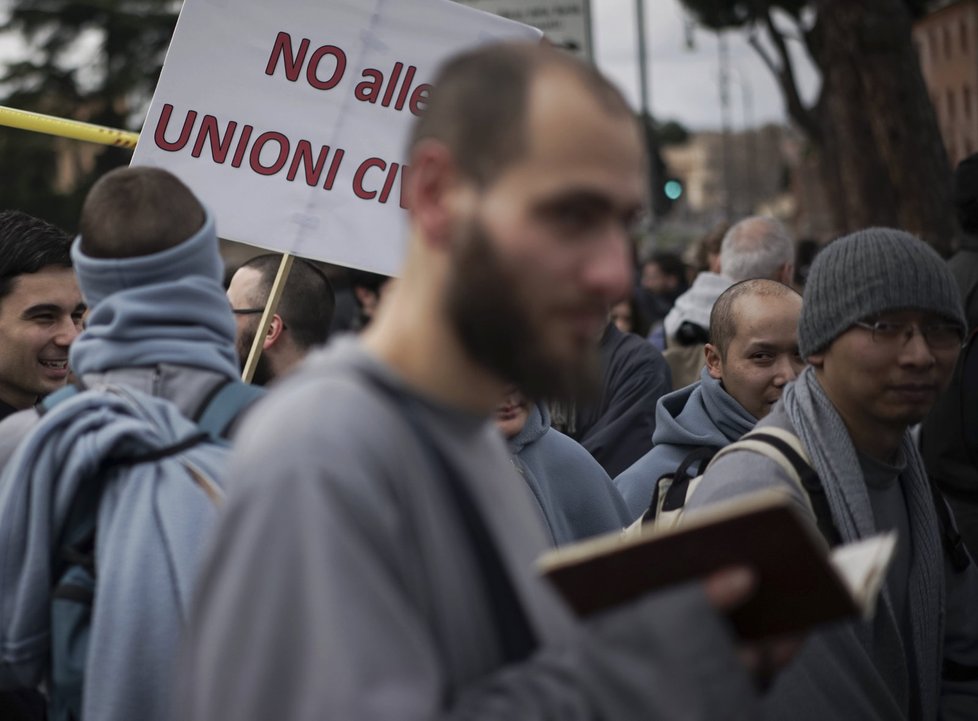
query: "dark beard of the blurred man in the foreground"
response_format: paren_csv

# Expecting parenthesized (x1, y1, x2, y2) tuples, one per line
(446, 221, 601, 402)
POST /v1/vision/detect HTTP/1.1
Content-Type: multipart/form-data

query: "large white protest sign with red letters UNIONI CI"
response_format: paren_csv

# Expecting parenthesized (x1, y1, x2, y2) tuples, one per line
(133, 0, 540, 275)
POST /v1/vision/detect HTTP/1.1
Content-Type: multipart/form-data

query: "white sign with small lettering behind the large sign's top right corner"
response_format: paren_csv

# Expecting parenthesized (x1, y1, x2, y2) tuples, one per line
(455, 0, 592, 62)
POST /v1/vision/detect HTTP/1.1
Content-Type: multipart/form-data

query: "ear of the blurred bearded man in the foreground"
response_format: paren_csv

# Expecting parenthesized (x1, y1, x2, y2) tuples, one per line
(403, 140, 459, 247)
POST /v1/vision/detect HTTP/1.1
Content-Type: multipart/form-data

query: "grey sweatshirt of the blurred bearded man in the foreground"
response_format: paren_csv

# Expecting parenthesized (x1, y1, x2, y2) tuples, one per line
(176, 340, 756, 721)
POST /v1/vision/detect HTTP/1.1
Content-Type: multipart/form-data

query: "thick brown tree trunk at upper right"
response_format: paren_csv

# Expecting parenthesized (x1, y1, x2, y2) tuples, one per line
(815, 0, 955, 254)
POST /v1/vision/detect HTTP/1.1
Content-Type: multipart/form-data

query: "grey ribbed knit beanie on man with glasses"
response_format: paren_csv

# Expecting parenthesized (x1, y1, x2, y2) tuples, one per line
(798, 228, 967, 358)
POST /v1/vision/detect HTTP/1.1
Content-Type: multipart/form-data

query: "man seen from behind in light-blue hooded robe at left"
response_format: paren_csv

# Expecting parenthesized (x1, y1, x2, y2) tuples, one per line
(0, 168, 250, 721)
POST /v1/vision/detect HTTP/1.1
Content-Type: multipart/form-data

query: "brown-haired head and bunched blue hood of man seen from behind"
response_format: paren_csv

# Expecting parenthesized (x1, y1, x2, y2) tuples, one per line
(0, 168, 238, 469)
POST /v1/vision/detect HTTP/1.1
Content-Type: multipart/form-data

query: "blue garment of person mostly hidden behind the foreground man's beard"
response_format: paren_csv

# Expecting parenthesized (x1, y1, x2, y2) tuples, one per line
(506, 405, 628, 545)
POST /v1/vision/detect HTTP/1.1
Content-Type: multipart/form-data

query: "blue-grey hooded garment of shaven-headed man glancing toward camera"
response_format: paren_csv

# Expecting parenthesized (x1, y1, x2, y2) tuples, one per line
(615, 368, 757, 520)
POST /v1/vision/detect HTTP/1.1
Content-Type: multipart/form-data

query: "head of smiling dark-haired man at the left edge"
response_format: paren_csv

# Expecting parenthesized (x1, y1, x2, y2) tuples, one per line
(0, 211, 85, 419)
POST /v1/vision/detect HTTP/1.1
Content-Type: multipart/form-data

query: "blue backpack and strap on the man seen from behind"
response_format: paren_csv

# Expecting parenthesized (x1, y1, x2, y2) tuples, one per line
(39, 380, 264, 721)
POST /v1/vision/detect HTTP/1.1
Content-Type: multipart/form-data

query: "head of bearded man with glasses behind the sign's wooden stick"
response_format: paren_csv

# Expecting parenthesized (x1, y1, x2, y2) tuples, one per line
(227, 253, 336, 386)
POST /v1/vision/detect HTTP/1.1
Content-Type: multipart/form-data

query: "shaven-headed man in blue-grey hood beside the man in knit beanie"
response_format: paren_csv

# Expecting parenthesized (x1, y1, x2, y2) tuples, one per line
(615, 279, 805, 519)
